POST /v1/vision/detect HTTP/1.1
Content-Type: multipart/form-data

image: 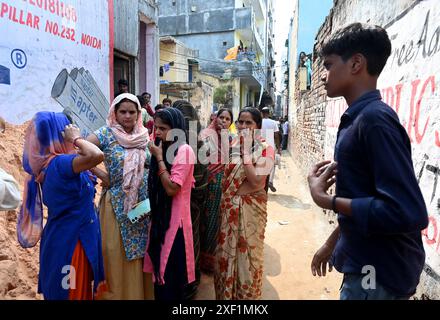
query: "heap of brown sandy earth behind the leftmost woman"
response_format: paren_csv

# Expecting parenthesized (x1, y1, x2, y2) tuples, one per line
(0, 123, 41, 300)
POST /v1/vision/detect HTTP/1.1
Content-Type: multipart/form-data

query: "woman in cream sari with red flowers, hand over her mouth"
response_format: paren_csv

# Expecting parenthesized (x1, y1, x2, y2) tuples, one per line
(214, 108, 274, 300)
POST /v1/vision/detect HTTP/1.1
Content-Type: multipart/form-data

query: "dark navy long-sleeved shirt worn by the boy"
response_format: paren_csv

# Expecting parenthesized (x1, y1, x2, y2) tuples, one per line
(333, 90, 428, 296)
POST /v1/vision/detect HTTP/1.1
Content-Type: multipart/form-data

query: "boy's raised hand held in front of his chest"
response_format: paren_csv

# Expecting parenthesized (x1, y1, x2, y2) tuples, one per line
(307, 160, 337, 209)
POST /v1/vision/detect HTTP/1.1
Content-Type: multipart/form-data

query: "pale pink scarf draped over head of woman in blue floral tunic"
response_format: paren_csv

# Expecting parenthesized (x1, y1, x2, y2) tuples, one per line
(107, 93, 149, 213)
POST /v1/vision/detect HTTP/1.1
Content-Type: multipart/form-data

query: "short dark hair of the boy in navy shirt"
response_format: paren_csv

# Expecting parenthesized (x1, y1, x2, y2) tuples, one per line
(321, 22, 391, 76)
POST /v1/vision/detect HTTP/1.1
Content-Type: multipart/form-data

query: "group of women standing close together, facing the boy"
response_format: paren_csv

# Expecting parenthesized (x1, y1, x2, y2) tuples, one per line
(5, 85, 274, 300)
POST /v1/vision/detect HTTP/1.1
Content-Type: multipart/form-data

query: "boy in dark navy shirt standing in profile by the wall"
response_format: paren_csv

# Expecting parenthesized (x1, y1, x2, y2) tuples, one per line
(308, 23, 428, 300)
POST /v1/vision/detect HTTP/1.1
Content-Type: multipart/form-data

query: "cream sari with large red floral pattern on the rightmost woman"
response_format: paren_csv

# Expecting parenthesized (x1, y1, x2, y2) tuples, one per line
(214, 138, 270, 300)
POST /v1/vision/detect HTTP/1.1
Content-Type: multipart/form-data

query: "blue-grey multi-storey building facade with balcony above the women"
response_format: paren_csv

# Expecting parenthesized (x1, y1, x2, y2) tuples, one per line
(159, 0, 273, 112)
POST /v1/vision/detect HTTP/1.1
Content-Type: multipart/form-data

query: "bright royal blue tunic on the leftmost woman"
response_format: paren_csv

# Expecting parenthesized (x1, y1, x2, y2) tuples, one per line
(38, 155, 104, 300)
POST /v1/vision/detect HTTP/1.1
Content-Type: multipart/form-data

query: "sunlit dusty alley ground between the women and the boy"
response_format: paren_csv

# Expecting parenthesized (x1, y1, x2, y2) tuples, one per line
(195, 151, 342, 300)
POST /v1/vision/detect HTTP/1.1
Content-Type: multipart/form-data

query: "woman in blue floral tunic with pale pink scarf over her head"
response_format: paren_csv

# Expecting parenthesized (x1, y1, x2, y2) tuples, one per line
(87, 93, 153, 300)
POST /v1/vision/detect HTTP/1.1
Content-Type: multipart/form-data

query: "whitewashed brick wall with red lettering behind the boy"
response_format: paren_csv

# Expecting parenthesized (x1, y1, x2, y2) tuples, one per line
(290, 0, 440, 299)
